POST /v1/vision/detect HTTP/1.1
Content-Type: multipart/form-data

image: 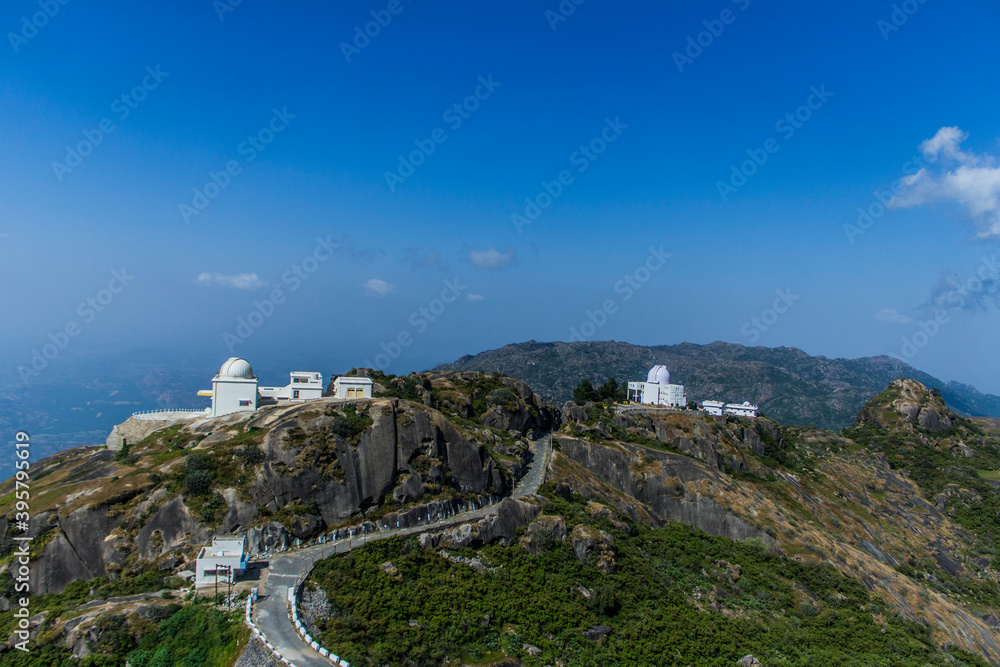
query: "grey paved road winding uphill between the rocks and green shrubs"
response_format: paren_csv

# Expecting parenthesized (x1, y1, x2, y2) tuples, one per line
(254, 435, 552, 667)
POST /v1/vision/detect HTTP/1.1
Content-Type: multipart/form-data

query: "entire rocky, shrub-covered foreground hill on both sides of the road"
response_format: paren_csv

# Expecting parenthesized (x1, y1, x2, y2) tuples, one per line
(9, 371, 1000, 666)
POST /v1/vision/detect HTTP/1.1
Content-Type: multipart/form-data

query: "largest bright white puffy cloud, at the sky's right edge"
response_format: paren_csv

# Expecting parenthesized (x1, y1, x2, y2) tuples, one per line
(890, 127, 1000, 239)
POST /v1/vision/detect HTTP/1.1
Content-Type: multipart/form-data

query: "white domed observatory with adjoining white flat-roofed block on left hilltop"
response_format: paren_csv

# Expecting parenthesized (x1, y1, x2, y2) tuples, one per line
(198, 357, 323, 417)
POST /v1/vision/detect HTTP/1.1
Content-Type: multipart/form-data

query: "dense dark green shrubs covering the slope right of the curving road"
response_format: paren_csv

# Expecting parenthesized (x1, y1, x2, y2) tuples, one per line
(310, 494, 986, 667)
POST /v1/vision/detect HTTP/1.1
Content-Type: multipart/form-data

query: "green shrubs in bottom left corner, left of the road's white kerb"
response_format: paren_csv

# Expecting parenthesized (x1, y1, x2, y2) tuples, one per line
(0, 602, 249, 667)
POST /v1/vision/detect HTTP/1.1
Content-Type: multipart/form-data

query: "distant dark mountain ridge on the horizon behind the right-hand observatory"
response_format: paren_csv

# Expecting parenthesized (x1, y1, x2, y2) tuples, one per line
(435, 340, 1000, 430)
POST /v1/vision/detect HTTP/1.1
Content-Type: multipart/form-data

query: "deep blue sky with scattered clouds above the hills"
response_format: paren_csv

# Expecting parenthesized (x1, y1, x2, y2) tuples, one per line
(0, 0, 1000, 393)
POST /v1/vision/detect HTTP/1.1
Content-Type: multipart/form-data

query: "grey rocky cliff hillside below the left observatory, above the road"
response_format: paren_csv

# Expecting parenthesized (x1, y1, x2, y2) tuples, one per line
(0, 374, 544, 594)
